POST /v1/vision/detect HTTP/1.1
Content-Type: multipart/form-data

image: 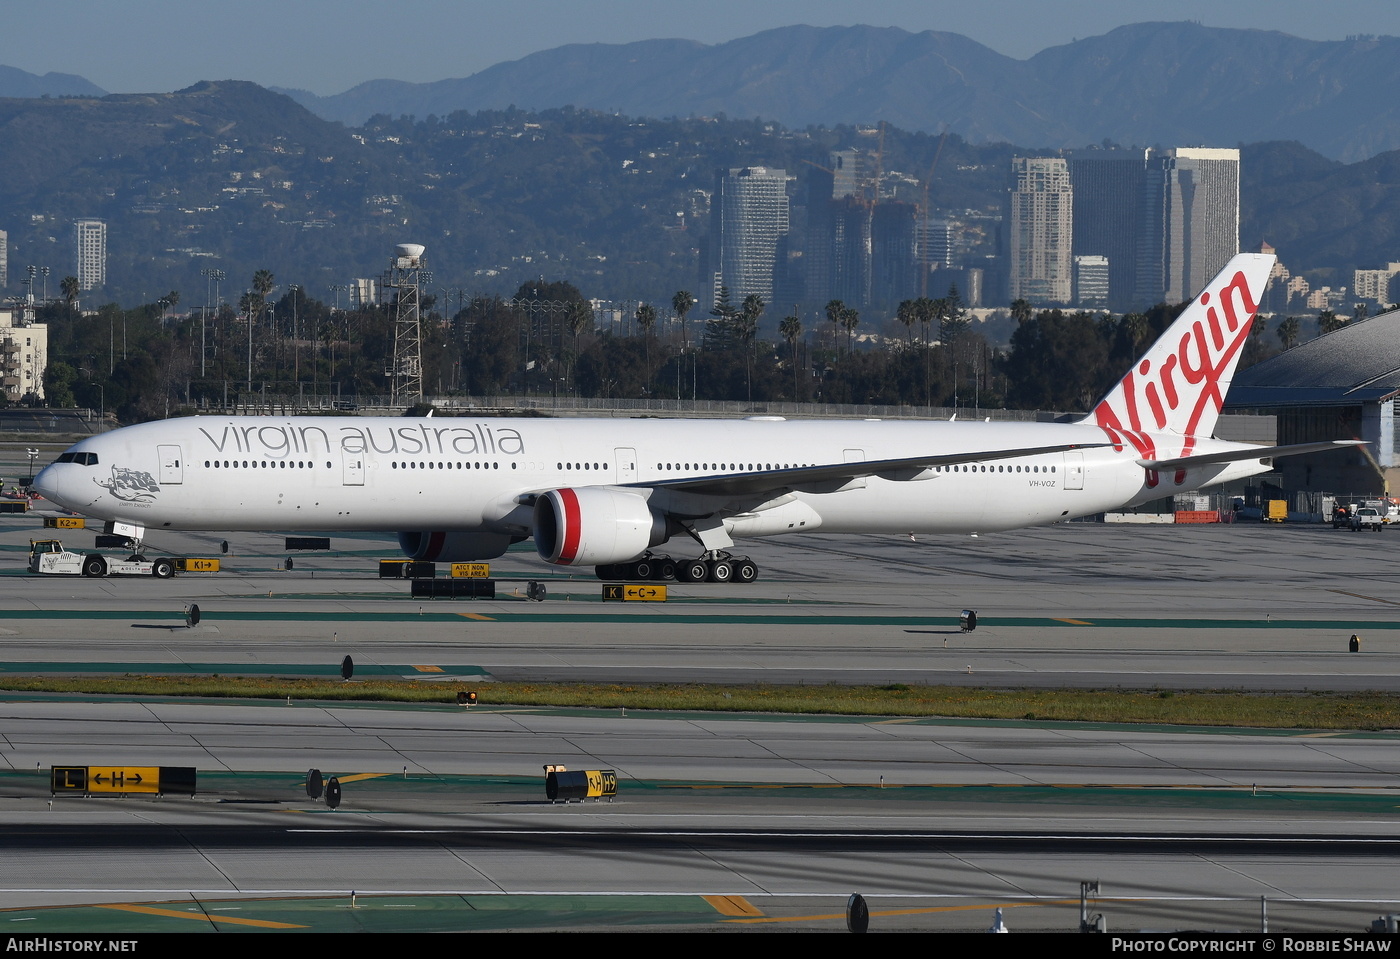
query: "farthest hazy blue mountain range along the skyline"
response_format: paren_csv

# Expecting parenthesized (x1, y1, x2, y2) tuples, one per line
(8, 22, 1400, 162)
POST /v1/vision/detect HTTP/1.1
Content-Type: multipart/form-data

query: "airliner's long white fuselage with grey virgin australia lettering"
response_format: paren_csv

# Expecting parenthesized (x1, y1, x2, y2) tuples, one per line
(36, 416, 1266, 554)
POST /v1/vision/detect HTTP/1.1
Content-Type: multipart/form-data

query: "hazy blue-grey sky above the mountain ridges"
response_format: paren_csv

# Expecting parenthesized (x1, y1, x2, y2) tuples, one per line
(8, 0, 1400, 95)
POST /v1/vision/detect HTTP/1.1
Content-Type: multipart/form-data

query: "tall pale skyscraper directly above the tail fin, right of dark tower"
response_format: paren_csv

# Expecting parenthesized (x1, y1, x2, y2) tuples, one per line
(1137, 147, 1239, 305)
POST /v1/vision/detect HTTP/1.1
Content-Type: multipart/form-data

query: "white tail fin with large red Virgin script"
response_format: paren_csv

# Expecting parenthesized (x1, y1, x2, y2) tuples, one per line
(1084, 253, 1274, 486)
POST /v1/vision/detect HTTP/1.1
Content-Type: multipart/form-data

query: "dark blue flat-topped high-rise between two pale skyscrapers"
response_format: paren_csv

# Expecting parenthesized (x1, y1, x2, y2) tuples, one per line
(1070, 150, 1151, 309)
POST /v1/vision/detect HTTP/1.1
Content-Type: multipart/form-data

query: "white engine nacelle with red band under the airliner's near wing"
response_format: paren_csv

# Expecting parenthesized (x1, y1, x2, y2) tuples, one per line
(535, 486, 666, 566)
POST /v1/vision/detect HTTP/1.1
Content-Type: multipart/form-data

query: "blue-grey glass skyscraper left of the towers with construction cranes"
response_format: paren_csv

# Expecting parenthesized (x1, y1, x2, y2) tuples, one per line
(710, 167, 788, 302)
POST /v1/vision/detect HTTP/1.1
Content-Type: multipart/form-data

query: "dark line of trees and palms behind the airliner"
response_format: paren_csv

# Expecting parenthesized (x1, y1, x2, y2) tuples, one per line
(16, 270, 1365, 423)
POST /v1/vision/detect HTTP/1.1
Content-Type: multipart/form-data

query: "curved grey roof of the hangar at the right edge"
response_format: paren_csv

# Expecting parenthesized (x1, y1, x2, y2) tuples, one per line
(1225, 309, 1400, 410)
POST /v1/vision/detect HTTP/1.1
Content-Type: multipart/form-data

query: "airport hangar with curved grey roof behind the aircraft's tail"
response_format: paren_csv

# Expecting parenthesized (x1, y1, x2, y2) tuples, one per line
(1225, 309, 1400, 496)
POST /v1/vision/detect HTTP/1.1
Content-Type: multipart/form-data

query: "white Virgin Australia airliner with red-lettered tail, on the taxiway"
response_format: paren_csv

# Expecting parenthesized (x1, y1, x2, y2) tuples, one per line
(35, 253, 1355, 581)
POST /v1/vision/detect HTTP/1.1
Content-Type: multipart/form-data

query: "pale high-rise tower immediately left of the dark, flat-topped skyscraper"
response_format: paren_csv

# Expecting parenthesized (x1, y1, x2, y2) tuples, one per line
(1007, 157, 1074, 304)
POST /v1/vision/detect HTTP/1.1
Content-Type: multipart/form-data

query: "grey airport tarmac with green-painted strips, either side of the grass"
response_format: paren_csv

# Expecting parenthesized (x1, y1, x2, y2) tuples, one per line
(0, 519, 1400, 931)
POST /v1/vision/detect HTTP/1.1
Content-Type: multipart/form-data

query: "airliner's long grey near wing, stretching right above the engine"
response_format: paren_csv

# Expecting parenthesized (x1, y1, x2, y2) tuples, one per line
(627, 442, 1110, 496)
